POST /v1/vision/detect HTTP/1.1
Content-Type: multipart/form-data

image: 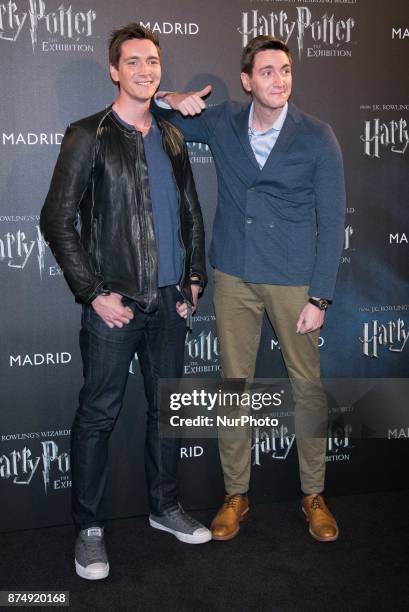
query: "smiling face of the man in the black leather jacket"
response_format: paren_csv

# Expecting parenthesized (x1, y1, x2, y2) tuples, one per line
(109, 38, 162, 103)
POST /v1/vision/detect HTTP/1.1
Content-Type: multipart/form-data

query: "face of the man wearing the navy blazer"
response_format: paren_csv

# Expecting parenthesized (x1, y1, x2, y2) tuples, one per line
(240, 49, 292, 111)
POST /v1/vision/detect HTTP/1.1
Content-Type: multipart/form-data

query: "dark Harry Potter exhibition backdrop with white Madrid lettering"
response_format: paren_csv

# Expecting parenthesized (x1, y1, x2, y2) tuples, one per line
(0, 0, 409, 529)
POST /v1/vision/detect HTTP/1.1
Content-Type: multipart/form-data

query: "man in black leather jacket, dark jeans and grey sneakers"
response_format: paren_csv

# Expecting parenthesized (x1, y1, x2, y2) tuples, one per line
(41, 24, 211, 580)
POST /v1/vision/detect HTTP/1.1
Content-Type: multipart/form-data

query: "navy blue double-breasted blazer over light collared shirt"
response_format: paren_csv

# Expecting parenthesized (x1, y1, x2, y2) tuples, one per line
(159, 102, 345, 299)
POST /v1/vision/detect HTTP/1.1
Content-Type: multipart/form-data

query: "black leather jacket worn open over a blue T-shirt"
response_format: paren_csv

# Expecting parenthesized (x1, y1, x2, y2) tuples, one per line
(40, 108, 207, 312)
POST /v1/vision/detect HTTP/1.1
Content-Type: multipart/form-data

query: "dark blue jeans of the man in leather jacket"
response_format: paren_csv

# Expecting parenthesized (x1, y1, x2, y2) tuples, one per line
(71, 285, 186, 529)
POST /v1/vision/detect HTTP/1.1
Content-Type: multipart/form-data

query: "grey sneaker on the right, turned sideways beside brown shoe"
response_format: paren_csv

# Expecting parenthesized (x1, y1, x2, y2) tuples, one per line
(149, 504, 212, 544)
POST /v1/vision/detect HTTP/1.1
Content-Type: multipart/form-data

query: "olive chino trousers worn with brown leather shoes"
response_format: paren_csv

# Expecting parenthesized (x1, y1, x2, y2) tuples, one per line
(214, 270, 328, 495)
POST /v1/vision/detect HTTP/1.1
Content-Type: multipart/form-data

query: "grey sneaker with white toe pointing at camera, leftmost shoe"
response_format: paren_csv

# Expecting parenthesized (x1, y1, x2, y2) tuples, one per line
(75, 527, 109, 580)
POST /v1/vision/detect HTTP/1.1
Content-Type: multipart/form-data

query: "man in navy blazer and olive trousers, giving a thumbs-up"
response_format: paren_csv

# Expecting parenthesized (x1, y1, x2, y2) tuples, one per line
(159, 36, 345, 542)
